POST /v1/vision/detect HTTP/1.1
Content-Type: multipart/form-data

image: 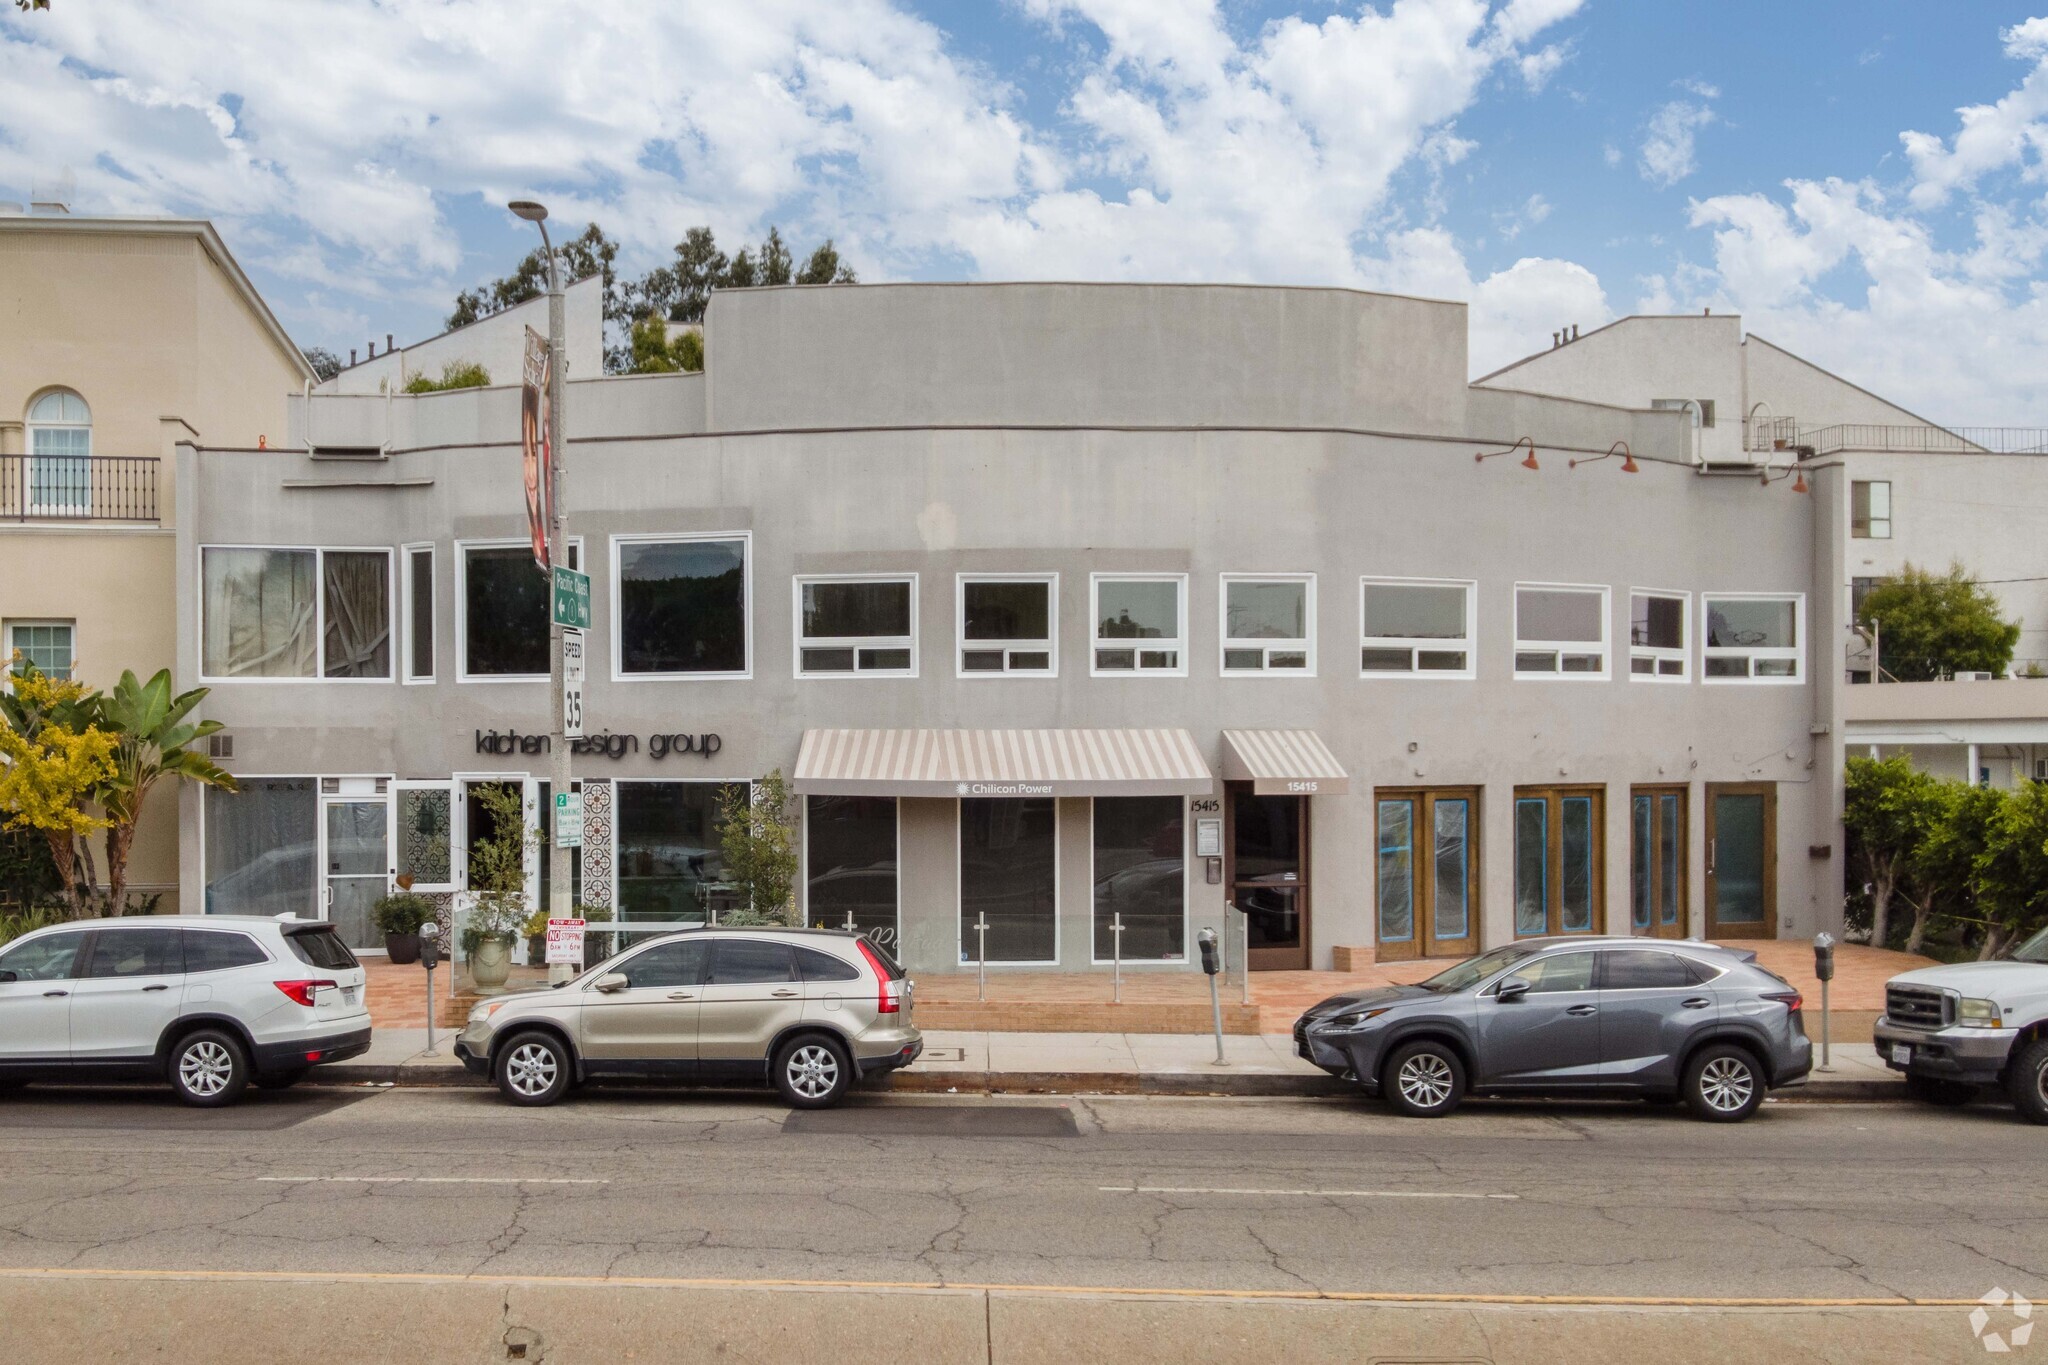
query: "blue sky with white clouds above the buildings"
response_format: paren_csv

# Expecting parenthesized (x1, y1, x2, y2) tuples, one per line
(12, 0, 2048, 426)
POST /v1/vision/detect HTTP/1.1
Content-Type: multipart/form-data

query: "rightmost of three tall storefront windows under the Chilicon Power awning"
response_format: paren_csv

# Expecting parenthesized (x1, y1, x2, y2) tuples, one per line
(1094, 796, 1188, 962)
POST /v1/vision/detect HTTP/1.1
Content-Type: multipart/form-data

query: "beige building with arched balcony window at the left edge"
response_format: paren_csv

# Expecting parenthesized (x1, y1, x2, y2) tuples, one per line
(0, 213, 313, 911)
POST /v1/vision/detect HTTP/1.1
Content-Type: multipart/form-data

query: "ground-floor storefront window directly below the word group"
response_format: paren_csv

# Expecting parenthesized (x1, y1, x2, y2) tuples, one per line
(614, 782, 737, 921)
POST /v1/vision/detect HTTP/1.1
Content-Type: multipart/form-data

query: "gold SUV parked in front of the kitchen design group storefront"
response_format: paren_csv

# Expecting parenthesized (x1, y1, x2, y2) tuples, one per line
(455, 929, 924, 1109)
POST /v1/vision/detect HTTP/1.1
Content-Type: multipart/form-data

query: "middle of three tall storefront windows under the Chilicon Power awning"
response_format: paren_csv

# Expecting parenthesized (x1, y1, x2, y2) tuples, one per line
(961, 796, 1059, 962)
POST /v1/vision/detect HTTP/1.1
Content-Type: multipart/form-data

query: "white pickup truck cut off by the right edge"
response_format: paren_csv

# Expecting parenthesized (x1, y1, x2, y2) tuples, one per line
(1876, 929, 2048, 1124)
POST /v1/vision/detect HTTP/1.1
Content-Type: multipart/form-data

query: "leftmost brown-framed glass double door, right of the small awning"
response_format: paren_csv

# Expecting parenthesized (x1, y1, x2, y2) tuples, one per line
(1374, 788, 1479, 962)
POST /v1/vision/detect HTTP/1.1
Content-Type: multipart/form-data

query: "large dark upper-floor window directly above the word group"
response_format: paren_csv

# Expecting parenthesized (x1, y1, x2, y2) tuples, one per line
(612, 530, 754, 681)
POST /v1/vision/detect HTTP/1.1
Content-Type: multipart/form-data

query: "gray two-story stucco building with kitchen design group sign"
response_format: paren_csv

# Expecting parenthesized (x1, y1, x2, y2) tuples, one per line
(174, 284, 1849, 972)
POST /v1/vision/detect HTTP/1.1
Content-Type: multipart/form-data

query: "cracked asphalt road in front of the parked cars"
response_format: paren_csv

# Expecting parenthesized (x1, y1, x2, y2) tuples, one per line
(0, 1089, 2048, 1300)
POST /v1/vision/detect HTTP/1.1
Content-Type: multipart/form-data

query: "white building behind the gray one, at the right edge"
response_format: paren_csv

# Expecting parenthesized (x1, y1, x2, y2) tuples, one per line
(1479, 315, 2048, 788)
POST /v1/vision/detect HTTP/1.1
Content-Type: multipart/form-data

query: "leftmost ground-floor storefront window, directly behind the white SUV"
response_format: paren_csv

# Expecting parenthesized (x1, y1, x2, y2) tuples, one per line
(205, 778, 319, 915)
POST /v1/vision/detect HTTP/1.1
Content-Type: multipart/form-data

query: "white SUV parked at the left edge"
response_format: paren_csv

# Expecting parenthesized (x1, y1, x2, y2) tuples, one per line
(0, 915, 371, 1107)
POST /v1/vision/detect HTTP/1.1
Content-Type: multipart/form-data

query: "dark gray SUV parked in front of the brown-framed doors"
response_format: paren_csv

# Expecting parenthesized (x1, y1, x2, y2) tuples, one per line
(1294, 937, 1812, 1124)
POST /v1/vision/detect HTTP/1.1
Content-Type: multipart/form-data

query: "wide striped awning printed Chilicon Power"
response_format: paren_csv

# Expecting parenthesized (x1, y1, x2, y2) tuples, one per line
(795, 731, 1217, 796)
